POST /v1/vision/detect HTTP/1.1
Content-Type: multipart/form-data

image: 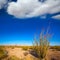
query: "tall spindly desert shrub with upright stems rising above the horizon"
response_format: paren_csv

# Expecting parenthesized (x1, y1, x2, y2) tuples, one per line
(33, 28, 49, 60)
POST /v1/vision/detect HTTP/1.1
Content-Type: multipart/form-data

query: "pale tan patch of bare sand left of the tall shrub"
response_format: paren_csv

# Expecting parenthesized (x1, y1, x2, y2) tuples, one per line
(6, 48, 28, 59)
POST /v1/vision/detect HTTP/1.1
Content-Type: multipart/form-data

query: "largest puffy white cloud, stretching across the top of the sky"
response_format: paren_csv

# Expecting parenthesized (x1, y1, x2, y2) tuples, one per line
(7, 0, 60, 18)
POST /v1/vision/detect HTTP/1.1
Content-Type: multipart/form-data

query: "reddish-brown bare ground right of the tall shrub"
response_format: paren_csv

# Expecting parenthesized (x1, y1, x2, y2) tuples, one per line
(47, 50, 60, 60)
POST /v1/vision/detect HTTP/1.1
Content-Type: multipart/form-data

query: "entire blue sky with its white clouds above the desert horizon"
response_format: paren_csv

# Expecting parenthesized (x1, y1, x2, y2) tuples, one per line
(0, 0, 60, 45)
